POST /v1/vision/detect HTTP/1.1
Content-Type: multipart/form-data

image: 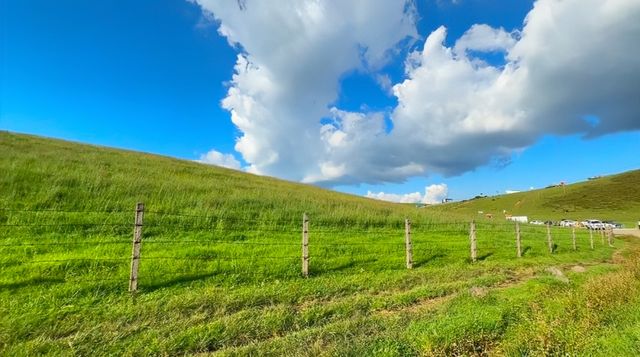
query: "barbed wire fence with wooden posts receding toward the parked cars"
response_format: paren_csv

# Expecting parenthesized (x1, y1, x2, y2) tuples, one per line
(0, 203, 614, 292)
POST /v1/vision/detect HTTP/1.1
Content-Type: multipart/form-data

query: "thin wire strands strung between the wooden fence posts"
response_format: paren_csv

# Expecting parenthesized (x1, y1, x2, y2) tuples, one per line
(0, 208, 620, 288)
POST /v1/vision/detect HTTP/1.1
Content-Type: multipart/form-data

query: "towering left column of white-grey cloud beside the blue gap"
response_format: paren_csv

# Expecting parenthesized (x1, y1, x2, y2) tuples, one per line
(190, 0, 417, 181)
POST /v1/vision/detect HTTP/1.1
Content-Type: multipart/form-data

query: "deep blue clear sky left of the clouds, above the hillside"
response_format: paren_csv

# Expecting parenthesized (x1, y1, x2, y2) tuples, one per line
(0, 1, 236, 159)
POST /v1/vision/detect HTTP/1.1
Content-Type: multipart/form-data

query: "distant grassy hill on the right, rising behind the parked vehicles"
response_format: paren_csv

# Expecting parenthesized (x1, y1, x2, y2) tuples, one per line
(433, 170, 640, 227)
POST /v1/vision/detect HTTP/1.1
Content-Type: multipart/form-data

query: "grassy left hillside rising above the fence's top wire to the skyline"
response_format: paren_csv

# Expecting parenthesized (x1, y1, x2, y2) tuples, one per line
(0, 132, 444, 224)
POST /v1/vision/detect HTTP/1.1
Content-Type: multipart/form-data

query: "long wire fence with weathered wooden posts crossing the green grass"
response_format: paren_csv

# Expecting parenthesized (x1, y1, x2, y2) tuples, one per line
(0, 203, 614, 292)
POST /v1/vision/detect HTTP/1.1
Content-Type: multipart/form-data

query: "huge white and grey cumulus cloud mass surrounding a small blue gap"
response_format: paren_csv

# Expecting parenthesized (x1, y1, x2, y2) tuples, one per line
(196, 0, 640, 186)
